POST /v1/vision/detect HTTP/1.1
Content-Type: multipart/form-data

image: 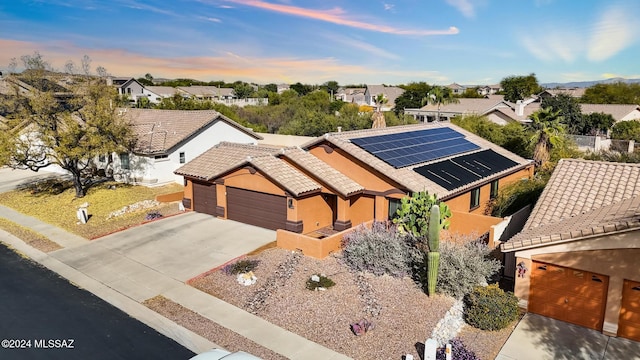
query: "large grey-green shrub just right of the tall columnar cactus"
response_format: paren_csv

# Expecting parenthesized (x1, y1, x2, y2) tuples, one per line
(436, 239, 502, 299)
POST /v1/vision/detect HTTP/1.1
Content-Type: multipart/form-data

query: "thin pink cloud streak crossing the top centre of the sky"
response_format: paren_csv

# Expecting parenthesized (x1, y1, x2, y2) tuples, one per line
(226, 0, 460, 36)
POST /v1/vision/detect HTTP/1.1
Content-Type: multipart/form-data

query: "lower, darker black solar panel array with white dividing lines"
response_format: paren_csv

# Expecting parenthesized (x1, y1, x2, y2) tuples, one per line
(413, 150, 518, 190)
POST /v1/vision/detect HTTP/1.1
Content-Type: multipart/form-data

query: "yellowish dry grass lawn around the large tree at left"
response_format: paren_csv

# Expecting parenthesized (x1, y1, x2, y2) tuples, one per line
(0, 179, 183, 239)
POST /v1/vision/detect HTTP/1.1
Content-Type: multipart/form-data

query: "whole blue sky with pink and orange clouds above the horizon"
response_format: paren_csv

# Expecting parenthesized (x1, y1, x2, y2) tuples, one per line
(0, 0, 640, 85)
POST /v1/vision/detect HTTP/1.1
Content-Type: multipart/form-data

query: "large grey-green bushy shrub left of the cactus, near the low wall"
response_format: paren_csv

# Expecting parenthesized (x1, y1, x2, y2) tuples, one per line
(342, 222, 417, 277)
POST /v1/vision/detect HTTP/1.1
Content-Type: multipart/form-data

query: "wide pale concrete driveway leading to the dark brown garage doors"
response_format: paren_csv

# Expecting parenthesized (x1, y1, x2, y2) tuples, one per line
(49, 212, 276, 301)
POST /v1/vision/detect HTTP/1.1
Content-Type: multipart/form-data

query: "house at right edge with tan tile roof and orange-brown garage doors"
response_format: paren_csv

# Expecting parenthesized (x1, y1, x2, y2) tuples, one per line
(501, 159, 640, 341)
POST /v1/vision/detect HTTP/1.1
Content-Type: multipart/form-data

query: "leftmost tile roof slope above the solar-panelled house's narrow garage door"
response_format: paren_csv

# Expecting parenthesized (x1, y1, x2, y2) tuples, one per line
(174, 142, 279, 180)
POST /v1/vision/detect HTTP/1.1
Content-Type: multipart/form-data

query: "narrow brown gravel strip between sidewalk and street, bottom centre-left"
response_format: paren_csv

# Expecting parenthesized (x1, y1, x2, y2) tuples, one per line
(143, 295, 286, 360)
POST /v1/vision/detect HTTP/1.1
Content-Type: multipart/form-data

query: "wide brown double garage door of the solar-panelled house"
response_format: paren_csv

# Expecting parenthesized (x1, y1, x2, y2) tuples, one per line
(227, 187, 287, 230)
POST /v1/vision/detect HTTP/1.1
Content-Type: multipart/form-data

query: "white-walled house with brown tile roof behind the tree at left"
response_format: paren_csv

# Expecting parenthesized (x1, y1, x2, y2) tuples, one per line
(106, 109, 261, 184)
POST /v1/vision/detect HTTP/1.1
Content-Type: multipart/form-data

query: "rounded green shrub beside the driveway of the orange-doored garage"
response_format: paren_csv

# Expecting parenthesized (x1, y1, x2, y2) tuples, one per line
(464, 284, 519, 330)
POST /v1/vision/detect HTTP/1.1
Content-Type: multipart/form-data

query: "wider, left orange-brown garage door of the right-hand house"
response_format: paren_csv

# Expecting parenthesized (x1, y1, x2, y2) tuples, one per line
(529, 261, 609, 331)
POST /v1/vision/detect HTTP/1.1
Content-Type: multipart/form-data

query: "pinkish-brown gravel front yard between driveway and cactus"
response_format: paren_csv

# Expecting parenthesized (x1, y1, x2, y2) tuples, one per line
(190, 249, 515, 359)
